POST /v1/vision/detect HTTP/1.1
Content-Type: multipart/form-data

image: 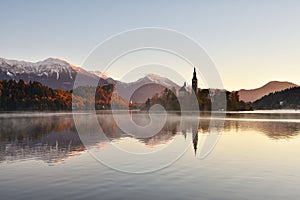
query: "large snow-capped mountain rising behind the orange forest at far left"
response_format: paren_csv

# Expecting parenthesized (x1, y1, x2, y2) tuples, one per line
(0, 58, 103, 90)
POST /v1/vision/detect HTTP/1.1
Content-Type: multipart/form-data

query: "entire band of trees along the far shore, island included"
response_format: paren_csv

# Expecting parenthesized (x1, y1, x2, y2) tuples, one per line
(7, 80, 300, 111)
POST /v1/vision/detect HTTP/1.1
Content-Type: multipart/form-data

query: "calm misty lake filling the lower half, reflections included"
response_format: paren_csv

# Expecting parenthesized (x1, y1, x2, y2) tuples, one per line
(0, 111, 300, 200)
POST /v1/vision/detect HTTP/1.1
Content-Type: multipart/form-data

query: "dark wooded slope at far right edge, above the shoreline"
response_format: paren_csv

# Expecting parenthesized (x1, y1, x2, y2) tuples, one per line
(253, 87, 300, 110)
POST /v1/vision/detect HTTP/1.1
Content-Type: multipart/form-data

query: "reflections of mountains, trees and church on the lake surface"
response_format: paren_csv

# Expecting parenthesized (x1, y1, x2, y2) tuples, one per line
(0, 113, 300, 163)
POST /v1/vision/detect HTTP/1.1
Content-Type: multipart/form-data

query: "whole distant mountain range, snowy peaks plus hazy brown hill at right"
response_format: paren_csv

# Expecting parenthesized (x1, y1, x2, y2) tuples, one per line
(0, 58, 297, 103)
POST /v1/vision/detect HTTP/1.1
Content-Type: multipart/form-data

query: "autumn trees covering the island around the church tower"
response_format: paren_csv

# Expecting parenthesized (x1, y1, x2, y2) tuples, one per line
(141, 88, 253, 111)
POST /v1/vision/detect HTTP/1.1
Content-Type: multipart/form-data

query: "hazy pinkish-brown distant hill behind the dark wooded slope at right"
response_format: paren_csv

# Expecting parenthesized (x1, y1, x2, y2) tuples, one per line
(238, 81, 298, 102)
